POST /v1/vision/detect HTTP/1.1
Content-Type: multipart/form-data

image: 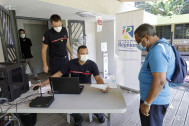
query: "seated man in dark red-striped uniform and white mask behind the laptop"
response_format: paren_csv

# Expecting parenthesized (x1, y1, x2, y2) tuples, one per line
(34, 45, 109, 126)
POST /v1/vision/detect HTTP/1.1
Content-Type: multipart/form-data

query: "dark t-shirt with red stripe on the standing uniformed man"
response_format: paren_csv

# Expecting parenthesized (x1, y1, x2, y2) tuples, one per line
(43, 27, 68, 57)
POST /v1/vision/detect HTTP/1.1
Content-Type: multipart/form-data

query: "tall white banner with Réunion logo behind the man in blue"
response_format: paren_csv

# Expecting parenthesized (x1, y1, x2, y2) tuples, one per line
(115, 10, 157, 91)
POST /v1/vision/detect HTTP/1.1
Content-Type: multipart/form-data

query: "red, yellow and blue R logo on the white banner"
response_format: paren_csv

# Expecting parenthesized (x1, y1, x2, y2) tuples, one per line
(122, 25, 134, 39)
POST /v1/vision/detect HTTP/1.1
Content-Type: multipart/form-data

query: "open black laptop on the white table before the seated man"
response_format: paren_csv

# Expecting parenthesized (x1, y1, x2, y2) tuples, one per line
(49, 77, 84, 94)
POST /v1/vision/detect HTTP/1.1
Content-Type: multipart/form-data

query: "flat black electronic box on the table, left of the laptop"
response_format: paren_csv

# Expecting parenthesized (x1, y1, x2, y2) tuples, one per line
(30, 96, 54, 107)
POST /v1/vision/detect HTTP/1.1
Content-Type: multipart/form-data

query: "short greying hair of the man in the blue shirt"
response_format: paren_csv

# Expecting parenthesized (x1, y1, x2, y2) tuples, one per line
(135, 24, 156, 38)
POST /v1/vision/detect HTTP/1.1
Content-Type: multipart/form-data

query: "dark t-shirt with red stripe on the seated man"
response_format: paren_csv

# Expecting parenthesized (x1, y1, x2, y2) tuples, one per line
(60, 58, 99, 83)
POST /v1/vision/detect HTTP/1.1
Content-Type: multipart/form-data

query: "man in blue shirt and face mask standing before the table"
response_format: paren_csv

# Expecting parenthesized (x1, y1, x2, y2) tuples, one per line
(135, 24, 175, 126)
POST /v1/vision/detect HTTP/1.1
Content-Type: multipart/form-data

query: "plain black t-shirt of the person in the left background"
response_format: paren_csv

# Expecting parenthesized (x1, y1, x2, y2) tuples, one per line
(20, 38, 33, 59)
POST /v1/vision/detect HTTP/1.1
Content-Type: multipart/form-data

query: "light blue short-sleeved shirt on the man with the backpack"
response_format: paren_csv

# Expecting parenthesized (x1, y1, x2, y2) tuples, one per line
(139, 38, 175, 105)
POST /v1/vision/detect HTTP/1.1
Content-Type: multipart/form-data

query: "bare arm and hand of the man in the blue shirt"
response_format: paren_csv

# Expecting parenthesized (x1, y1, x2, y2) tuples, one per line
(140, 72, 166, 116)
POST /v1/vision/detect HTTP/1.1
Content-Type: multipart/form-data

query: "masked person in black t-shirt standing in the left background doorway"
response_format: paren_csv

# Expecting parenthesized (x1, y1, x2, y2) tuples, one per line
(19, 29, 39, 80)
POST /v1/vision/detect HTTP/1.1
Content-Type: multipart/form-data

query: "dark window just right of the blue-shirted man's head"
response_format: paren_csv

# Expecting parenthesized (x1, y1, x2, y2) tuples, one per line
(156, 25, 171, 39)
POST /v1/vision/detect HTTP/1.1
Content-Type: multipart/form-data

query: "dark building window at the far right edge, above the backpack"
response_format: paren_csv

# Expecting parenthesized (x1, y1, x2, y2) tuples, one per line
(175, 24, 189, 39)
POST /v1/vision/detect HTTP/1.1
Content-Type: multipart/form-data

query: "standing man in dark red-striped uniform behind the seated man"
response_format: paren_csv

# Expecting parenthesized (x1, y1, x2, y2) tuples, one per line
(42, 14, 73, 75)
